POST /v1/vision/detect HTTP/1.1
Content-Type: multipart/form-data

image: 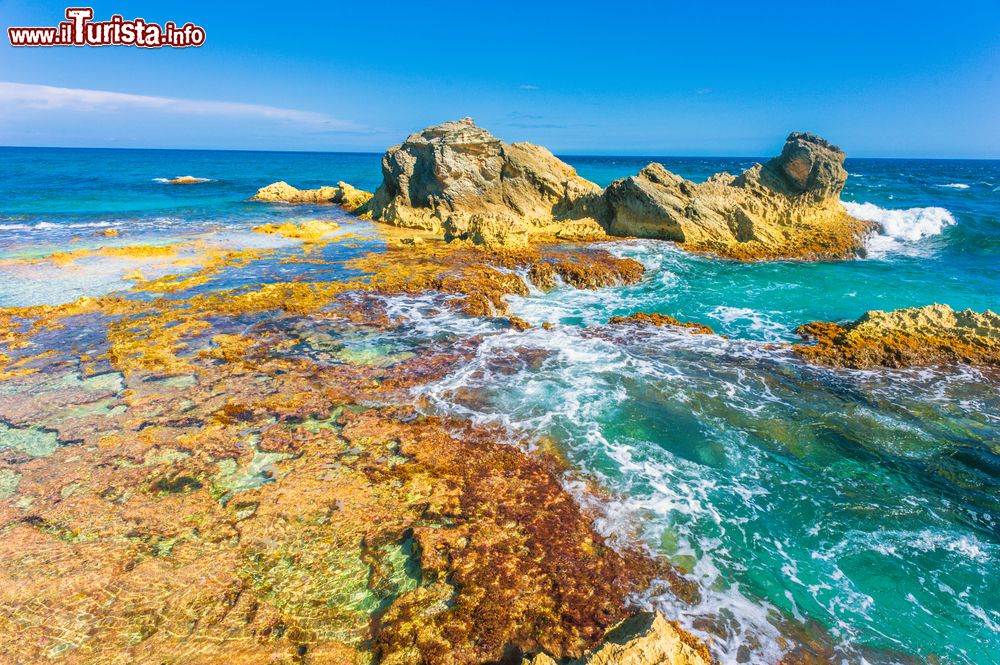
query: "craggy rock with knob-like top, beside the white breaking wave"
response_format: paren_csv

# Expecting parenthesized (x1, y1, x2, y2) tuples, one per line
(605, 133, 874, 259)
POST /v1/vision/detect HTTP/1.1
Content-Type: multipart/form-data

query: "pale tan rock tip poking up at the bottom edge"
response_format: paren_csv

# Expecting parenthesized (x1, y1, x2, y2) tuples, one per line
(522, 612, 712, 665)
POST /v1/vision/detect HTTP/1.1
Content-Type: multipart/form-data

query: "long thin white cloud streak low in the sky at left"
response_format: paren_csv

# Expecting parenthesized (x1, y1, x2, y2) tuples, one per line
(0, 81, 369, 132)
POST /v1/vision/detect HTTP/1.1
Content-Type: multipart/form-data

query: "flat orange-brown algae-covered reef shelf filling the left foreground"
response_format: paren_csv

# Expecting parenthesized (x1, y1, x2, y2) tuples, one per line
(0, 235, 703, 665)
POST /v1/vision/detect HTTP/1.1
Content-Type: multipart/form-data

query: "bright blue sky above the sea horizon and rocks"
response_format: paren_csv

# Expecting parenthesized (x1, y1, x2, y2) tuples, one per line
(0, 0, 1000, 159)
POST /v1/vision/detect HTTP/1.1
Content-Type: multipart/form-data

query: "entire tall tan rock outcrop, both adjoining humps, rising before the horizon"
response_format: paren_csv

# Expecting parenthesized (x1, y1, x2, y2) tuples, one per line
(359, 118, 875, 259)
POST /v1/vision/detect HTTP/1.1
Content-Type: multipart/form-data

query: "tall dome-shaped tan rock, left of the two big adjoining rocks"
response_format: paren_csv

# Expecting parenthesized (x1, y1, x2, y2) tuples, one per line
(362, 118, 604, 246)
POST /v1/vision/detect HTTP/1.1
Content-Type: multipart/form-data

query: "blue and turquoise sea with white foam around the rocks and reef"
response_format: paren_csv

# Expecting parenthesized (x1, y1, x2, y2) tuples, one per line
(0, 148, 1000, 664)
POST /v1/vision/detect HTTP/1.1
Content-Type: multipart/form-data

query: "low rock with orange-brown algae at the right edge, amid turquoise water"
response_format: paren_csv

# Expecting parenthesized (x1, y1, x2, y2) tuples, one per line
(793, 305, 1000, 368)
